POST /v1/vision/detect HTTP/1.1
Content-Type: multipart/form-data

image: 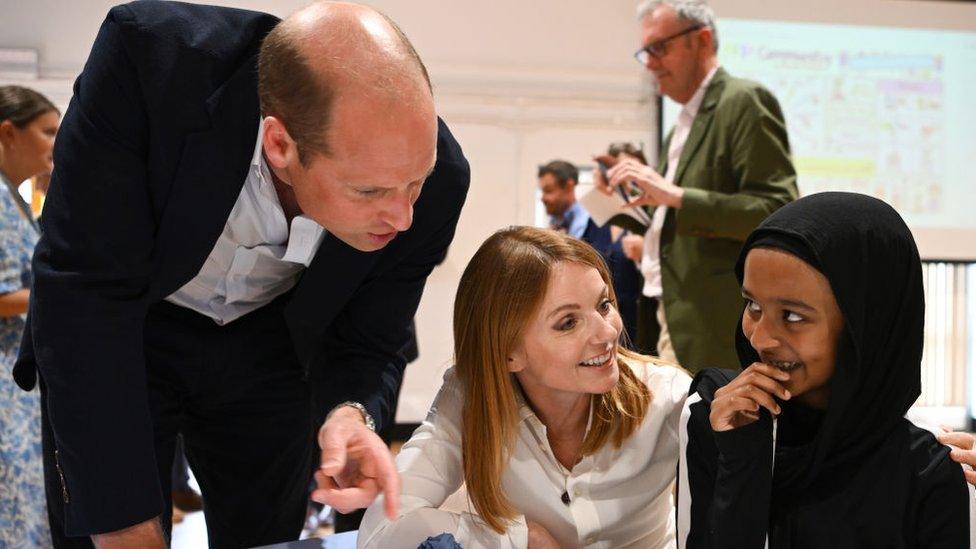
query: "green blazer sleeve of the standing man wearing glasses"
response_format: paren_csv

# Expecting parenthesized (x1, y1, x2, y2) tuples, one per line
(676, 88, 798, 240)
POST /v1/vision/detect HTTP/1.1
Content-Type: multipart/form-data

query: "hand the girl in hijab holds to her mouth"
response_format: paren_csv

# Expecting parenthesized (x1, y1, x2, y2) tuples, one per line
(708, 362, 791, 432)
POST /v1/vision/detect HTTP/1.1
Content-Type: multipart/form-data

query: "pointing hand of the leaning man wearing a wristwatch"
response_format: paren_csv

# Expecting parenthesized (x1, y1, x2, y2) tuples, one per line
(312, 406, 400, 520)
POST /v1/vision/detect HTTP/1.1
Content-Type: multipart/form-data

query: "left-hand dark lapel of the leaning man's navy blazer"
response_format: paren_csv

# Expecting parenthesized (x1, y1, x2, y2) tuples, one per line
(154, 56, 260, 297)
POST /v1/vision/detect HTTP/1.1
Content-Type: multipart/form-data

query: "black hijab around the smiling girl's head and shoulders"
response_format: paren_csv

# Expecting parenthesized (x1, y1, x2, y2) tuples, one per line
(736, 192, 925, 501)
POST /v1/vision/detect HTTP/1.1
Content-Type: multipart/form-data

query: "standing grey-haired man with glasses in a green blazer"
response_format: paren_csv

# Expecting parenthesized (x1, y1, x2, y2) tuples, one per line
(597, 0, 798, 372)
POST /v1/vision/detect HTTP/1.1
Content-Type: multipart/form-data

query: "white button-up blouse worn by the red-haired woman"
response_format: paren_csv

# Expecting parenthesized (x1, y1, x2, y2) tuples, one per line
(359, 363, 691, 549)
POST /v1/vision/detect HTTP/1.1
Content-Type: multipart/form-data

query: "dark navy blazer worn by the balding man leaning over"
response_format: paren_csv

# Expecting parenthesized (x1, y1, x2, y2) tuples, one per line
(15, 1, 470, 536)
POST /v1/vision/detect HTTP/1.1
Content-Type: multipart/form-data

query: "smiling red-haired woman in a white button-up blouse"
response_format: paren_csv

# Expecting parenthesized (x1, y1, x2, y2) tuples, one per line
(359, 227, 689, 548)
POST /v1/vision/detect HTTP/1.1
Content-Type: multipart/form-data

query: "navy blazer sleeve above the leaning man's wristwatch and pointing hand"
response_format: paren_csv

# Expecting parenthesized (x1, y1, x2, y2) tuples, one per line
(310, 122, 470, 429)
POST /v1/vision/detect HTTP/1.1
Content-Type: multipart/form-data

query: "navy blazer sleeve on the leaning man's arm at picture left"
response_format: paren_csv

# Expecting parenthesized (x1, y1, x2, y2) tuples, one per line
(22, 6, 163, 536)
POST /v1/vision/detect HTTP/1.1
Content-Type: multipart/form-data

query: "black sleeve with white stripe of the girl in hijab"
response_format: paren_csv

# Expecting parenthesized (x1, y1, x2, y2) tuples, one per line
(677, 395, 773, 549)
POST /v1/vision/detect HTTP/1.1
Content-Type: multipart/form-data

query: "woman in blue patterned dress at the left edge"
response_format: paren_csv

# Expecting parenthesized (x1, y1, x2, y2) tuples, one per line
(0, 86, 61, 548)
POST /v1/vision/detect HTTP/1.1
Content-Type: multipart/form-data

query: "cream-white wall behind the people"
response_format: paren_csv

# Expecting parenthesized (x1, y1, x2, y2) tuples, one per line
(0, 0, 976, 422)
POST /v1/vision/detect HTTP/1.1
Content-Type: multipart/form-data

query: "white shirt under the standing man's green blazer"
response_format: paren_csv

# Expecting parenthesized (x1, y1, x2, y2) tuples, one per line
(640, 65, 718, 298)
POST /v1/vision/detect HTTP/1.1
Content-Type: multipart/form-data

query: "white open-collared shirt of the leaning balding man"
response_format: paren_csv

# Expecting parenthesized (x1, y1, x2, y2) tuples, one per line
(166, 124, 325, 325)
